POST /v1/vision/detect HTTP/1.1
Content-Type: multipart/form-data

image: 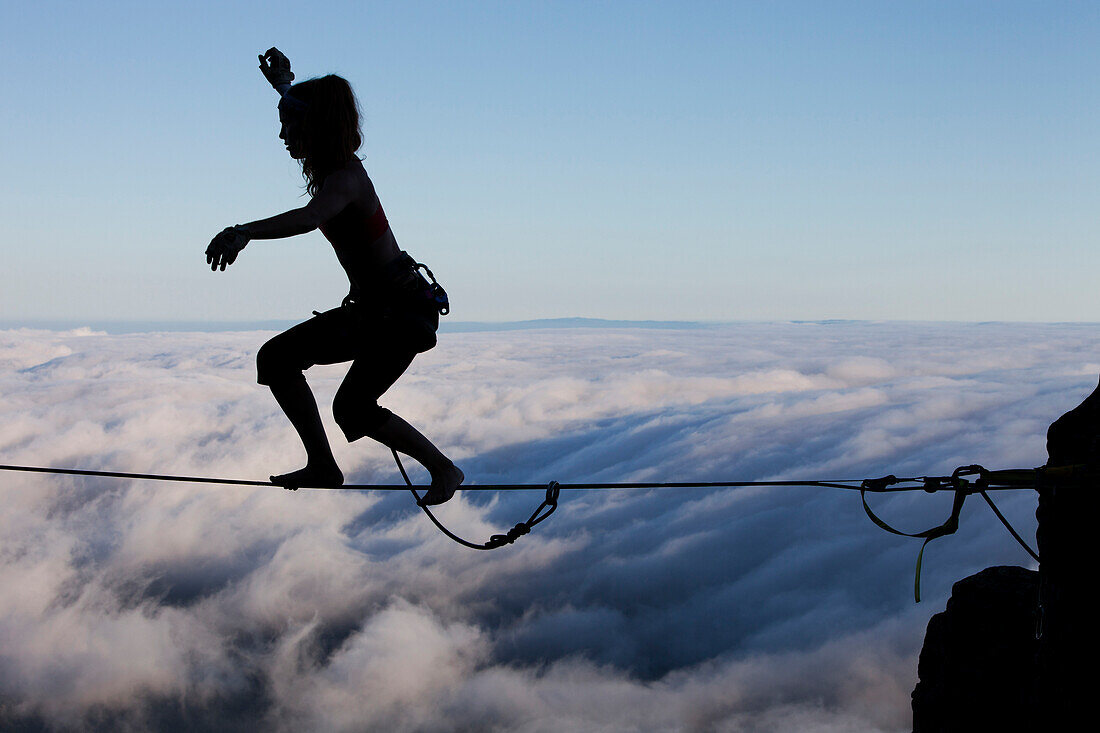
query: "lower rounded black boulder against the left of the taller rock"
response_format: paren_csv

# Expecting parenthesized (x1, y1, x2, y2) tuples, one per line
(913, 566, 1048, 733)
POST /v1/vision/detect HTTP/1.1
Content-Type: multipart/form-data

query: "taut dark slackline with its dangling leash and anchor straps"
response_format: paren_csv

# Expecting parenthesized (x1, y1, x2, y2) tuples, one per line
(0, 462, 1064, 602)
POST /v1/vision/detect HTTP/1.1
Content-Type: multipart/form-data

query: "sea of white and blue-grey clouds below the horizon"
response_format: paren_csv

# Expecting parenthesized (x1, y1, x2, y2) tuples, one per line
(0, 322, 1100, 732)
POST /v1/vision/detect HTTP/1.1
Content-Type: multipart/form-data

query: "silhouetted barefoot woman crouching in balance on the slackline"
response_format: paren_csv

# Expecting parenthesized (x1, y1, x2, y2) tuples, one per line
(207, 48, 463, 504)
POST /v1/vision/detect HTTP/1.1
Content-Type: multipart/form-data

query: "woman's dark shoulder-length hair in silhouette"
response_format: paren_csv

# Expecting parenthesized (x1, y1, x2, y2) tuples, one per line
(287, 74, 363, 196)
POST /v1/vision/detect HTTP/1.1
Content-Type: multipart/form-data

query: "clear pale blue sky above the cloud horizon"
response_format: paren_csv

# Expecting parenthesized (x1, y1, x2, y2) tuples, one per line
(0, 1, 1100, 321)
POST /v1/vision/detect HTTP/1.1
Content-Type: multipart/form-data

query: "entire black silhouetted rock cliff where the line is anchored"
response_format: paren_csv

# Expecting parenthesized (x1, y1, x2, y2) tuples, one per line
(913, 376, 1100, 733)
